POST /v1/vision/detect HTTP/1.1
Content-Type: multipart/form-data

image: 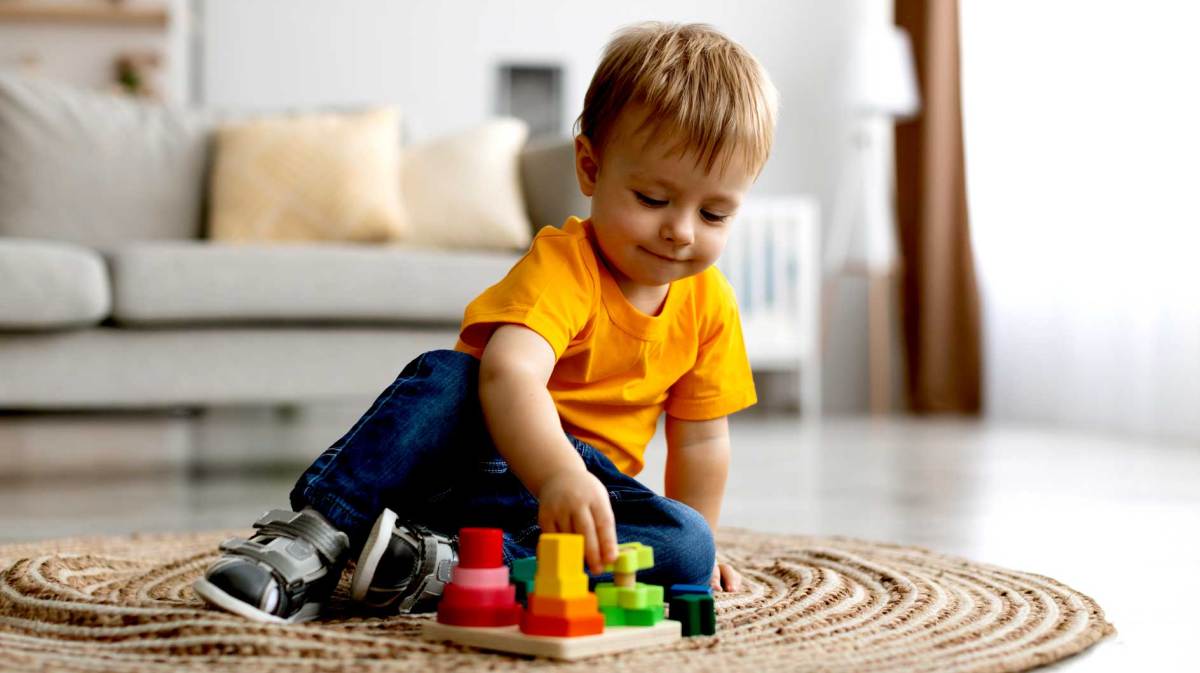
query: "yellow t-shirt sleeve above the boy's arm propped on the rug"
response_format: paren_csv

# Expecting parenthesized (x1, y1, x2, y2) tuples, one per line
(666, 270, 758, 421)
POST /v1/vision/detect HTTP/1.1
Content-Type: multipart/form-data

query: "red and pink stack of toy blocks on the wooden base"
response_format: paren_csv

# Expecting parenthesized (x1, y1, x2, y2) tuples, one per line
(437, 528, 521, 626)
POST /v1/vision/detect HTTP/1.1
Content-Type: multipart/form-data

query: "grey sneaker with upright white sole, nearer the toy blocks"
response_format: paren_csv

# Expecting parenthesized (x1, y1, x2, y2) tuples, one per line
(350, 509, 458, 613)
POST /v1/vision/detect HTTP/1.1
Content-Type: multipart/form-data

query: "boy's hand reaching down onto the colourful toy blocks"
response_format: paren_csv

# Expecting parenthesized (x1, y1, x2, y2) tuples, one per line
(535, 469, 617, 575)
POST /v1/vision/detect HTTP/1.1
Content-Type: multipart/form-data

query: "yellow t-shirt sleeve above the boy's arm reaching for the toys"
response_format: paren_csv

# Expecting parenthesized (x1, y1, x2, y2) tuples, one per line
(455, 228, 596, 359)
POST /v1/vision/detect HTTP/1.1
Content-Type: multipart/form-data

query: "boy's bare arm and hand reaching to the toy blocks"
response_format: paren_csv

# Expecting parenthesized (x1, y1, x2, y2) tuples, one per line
(479, 325, 617, 573)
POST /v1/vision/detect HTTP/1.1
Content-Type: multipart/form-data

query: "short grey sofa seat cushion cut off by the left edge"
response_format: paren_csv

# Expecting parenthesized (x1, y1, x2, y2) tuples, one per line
(0, 239, 112, 330)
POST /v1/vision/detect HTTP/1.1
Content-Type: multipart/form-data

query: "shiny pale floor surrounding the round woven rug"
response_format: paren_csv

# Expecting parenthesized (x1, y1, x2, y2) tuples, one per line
(0, 405, 1200, 671)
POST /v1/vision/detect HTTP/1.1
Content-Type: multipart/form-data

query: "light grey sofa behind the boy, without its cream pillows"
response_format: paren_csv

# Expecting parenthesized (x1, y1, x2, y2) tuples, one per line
(0, 74, 587, 410)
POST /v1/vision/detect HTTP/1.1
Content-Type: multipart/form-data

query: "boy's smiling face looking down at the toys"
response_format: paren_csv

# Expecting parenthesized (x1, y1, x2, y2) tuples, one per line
(575, 106, 755, 296)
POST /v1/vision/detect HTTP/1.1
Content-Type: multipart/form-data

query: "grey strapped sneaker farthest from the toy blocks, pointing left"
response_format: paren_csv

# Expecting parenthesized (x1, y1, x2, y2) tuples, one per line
(192, 510, 350, 624)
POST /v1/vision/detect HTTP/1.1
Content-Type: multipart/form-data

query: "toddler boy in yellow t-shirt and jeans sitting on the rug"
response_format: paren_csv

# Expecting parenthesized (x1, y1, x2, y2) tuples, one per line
(194, 23, 776, 621)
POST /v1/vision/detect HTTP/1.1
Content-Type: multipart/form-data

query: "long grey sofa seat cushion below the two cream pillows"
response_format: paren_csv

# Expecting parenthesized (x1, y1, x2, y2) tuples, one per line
(108, 241, 518, 325)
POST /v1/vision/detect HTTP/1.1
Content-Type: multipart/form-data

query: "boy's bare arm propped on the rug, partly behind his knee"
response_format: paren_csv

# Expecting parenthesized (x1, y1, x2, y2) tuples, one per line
(665, 415, 742, 591)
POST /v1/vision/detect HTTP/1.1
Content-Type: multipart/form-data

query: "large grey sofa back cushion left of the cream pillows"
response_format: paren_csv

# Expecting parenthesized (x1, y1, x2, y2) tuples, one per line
(0, 74, 209, 244)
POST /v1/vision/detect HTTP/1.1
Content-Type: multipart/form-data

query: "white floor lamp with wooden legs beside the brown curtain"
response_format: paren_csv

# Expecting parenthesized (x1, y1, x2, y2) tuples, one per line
(824, 23, 920, 414)
